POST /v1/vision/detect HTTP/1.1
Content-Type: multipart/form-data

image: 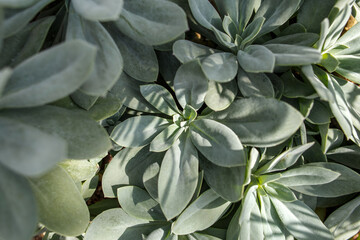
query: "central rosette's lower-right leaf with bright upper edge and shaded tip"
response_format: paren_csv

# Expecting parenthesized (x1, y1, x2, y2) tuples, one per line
(190, 119, 246, 167)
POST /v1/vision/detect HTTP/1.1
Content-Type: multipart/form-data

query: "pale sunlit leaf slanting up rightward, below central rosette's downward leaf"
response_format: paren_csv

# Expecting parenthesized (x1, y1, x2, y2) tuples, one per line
(172, 189, 231, 235)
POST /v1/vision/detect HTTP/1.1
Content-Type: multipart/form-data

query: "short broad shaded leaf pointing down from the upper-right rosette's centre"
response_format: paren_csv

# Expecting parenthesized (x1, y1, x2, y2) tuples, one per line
(237, 45, 276, 73)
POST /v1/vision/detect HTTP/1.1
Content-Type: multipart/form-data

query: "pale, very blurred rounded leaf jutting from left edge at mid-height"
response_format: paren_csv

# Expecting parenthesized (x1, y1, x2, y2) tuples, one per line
(0, 117, 67, 176)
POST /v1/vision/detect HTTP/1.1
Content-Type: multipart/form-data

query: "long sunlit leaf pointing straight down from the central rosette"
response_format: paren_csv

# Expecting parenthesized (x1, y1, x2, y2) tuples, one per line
(158, 134, 199, 220)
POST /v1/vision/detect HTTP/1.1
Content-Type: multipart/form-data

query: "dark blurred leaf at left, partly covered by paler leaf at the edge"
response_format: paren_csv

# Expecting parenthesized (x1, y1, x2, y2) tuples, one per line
(1, 106, 111, 159)
